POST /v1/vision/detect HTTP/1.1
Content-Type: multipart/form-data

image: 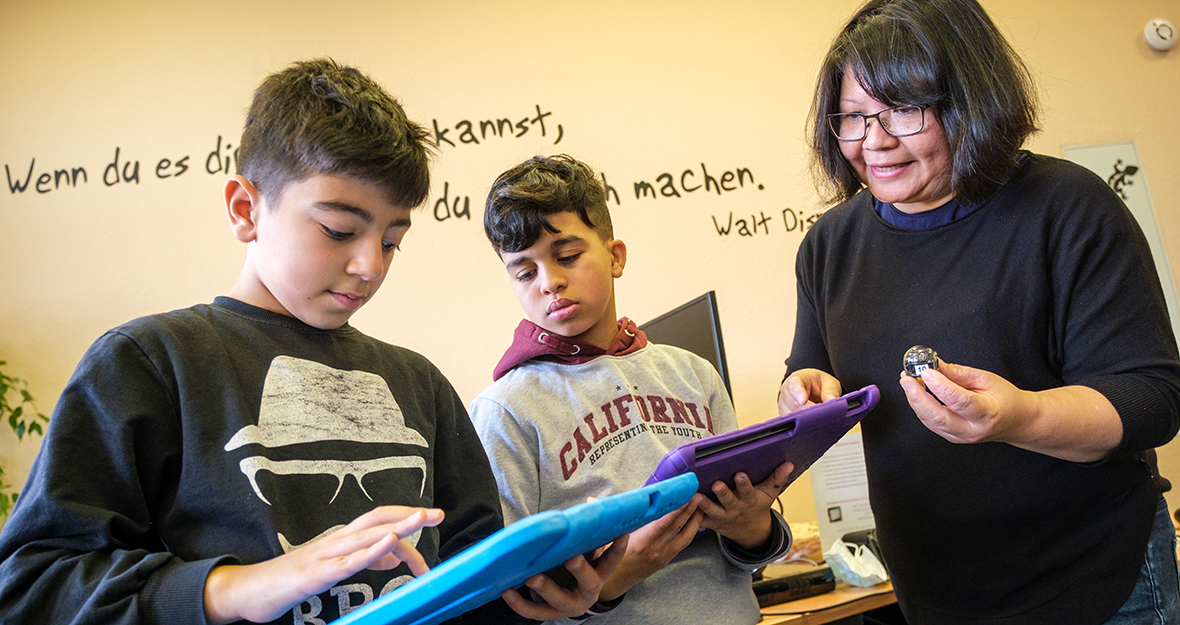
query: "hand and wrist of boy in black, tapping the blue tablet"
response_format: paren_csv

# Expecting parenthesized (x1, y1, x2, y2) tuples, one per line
(204, 506, 443, 623)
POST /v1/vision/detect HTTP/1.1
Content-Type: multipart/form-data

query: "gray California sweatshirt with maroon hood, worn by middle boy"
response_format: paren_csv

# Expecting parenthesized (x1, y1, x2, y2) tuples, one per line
(471, 317, 791, 624)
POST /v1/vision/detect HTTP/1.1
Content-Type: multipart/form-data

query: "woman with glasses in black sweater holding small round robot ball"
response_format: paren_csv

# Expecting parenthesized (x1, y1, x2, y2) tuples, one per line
(779, 0, 1180, 625)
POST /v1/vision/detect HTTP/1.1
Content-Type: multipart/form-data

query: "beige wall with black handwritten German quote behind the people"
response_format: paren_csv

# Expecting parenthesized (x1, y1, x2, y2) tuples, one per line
(0, 0, 1180, 520)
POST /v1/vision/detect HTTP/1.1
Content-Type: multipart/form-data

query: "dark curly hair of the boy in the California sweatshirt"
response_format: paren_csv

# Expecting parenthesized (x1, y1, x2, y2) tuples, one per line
(484, 154, 615, 254)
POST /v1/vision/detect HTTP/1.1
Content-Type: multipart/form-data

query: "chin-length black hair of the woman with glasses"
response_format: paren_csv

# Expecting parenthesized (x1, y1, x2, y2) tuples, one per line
(809, 0, 1040, 205)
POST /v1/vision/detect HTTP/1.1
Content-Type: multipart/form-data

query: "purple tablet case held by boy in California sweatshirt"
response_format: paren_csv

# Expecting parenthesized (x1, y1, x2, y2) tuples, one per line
(647, 384, 880, 499)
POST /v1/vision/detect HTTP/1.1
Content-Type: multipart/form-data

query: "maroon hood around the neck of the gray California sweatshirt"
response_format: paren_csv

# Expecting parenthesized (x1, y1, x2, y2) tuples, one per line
(492, 317, 648, 381)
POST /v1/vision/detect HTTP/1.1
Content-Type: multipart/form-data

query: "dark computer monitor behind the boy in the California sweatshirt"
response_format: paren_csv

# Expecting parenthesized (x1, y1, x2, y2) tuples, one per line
(640, 291, 733, 397)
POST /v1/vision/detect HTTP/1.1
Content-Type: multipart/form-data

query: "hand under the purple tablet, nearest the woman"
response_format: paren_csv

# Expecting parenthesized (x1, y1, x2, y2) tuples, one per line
(693, 462, 795, 551)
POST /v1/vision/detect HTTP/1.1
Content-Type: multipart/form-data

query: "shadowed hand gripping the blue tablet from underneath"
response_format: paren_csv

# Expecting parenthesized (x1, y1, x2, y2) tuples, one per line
(500, 534, 629, 620)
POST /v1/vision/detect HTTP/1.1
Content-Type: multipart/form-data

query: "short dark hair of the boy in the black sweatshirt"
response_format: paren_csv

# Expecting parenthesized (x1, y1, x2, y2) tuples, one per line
(237, 59, 432, 208)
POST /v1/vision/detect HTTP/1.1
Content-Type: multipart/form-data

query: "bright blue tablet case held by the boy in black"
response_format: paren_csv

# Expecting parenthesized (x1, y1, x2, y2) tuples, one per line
(333, 473, 696, 625)
